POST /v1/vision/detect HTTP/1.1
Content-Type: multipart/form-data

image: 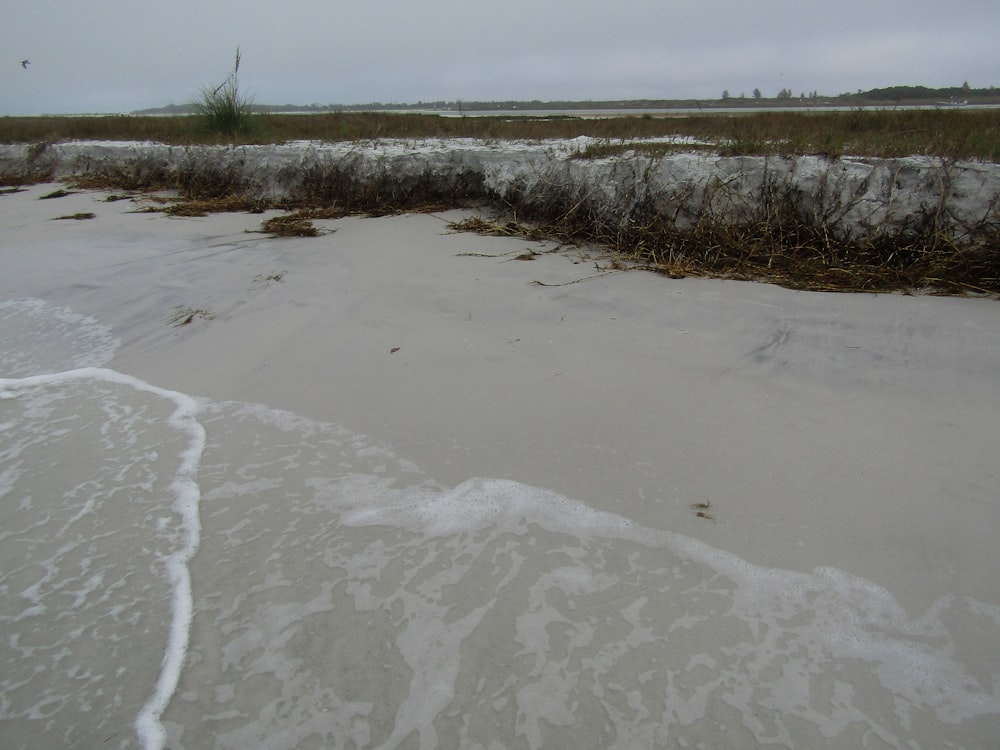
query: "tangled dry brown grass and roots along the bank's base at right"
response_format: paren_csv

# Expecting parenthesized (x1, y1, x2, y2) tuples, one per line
(492, 164, 1000, 294)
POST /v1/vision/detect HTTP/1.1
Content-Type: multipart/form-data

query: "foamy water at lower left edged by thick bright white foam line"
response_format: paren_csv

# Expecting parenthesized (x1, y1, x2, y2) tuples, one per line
(0, 368, 205, 748)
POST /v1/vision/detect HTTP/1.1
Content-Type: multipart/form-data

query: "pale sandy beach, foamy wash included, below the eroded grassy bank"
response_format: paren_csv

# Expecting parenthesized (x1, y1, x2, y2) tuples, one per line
(0, 184, 1000, 749)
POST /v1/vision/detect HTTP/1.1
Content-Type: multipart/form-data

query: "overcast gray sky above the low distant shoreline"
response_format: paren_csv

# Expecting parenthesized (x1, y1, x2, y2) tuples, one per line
(0, 0, 1000, 115)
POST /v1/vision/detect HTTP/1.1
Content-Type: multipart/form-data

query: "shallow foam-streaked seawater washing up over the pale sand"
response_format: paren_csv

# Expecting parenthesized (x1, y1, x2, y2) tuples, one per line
(0, 299, 1000, 748)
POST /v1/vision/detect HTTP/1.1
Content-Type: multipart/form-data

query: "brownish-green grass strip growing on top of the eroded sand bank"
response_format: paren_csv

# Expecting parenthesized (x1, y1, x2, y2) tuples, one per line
(0, 107, 1000, 162)
